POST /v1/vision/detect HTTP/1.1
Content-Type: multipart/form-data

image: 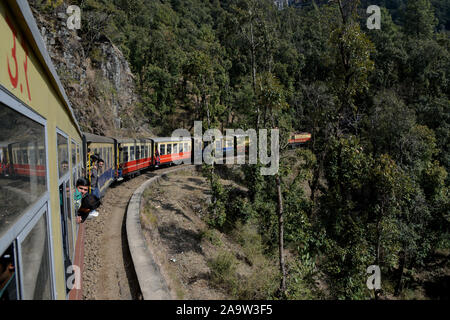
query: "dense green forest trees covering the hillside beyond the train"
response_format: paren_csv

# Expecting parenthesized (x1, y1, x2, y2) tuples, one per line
(33, 0, 450, 299)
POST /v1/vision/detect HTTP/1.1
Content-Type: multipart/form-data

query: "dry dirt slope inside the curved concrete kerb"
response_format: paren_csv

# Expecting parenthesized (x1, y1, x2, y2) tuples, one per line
(141, 171, 277, 300)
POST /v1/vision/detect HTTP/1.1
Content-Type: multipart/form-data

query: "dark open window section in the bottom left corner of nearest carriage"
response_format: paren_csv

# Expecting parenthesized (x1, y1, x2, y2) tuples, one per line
(0, 244, 18, 301)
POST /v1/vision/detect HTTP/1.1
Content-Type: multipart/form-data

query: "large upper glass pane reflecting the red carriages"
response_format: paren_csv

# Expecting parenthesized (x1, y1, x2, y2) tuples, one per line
(0, 103, 47, 238)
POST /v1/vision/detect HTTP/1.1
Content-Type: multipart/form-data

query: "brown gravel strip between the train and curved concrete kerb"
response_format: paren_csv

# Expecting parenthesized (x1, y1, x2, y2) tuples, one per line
(82, 166, 190, 300)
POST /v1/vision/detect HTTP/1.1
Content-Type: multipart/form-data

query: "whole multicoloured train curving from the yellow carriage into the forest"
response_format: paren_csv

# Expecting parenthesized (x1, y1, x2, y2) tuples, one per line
(0, 0, 310, 301)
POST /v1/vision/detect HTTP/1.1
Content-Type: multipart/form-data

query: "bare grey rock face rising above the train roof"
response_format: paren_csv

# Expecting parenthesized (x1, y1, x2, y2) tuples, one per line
(30, 1, 151, 137)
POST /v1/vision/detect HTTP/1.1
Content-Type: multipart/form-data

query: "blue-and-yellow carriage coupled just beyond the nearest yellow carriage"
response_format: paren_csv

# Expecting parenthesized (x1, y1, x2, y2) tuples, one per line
(83, 132, 118, 197)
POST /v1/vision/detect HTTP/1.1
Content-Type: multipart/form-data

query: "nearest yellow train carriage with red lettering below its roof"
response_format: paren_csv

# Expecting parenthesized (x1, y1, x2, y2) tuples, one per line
(0, 0, 82, 300)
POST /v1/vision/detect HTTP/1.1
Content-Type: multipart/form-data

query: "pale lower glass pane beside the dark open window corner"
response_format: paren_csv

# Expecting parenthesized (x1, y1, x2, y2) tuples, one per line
(21, 213, 52, 300)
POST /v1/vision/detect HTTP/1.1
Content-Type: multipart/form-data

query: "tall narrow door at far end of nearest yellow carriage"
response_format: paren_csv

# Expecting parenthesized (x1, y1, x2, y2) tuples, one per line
(57, 130, 74, 294)
